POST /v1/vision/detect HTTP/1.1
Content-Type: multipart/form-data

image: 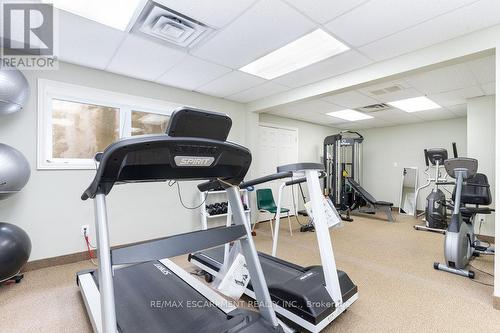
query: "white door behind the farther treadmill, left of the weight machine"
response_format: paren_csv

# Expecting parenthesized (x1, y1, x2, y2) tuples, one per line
(257, 124, 298, 221)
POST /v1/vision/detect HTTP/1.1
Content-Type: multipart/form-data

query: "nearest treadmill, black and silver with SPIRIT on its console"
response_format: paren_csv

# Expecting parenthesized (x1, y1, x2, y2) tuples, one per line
(77, 108, 290, 333)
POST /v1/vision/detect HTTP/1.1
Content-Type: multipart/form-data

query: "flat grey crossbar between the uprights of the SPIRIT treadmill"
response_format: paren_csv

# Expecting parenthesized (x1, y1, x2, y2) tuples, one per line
(111, 225, 246, 265)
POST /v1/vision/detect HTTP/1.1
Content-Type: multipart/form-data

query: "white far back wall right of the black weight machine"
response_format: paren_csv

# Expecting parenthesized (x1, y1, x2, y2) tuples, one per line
(359, 118, 467, 213)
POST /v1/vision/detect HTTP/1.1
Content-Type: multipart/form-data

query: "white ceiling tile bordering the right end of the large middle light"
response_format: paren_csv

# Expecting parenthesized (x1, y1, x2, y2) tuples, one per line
(325, 0, 475, 46)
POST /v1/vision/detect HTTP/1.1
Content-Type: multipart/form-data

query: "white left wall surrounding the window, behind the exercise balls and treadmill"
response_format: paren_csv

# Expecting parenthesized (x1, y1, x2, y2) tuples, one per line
(0, 63, 246, 260)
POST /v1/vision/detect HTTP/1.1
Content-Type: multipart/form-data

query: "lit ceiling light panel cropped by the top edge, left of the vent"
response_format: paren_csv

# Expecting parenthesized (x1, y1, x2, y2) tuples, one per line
(42, 0, 143, 31)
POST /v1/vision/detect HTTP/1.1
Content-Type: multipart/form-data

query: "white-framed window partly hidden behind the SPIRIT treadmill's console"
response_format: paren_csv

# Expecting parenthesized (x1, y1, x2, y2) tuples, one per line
(37, 80, 180, 169)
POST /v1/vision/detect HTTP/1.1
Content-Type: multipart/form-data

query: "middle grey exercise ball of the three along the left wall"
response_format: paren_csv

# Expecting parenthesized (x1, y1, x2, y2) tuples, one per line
(0, 143, 31, 200)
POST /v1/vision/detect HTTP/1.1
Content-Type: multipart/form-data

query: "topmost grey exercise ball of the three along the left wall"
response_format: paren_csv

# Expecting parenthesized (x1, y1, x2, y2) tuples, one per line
(0, 67, 30, 115)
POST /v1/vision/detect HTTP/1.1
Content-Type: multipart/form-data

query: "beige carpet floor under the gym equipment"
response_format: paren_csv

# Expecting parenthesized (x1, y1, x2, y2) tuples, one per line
(0, 211, 500, 333)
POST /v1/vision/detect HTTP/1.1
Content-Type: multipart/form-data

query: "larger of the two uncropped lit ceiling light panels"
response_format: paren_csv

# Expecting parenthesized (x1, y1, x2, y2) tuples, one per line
(240, 29, 349, 80)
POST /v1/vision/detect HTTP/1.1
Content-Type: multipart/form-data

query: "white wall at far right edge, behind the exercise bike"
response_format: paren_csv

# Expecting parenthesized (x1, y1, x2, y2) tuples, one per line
(467, 95, 495, 236)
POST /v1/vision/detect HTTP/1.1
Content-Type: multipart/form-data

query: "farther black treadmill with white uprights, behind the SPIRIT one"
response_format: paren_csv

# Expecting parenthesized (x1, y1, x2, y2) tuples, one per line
(188, 163, 358, 332)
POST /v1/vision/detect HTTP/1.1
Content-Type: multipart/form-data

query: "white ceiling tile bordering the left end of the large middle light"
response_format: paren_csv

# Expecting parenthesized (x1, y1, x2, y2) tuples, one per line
(196, 71, 266, 97)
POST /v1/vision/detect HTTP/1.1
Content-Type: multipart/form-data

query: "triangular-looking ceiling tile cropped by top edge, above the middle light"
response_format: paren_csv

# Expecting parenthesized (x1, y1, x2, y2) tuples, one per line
(285, 0, 368, 24)
